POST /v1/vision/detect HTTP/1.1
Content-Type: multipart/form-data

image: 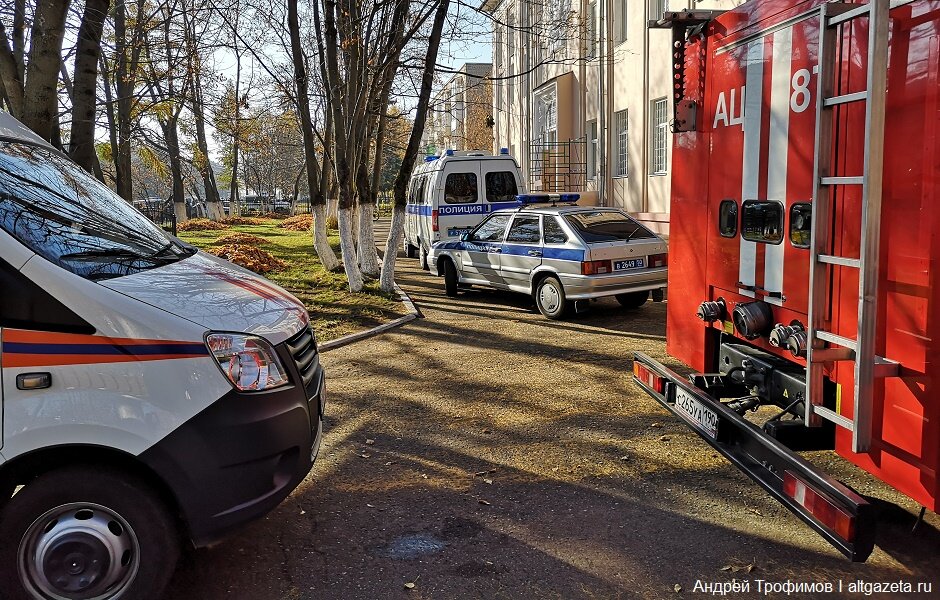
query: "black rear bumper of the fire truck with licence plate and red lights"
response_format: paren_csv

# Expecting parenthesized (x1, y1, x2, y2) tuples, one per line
(633, 352, 877, 562)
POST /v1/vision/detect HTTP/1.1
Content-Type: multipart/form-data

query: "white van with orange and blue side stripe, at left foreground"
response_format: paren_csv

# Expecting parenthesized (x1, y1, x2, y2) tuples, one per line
(0, 112, 324, 600)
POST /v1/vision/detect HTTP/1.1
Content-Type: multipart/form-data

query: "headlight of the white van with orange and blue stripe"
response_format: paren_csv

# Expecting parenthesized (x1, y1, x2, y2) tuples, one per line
(206, 333, 288, 392)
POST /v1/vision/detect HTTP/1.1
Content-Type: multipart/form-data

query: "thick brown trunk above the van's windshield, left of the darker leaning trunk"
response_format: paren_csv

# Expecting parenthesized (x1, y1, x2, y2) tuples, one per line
(21, 0, 69, 141)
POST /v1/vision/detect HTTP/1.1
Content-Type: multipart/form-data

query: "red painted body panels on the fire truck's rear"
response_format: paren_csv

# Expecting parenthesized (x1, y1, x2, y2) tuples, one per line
(667, 0, 940, 510)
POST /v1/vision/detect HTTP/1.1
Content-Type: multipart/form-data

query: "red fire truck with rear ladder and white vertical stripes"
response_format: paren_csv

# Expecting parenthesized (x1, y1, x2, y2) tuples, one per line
(634, 0, 940, 561)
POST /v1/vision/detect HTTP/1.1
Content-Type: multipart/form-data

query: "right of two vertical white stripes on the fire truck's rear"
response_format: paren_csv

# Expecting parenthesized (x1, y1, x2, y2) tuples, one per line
(764, 28, 793, 305)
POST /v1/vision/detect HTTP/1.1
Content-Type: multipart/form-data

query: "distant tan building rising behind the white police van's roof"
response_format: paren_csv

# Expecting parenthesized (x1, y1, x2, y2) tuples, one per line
(421, 63, 494, 154)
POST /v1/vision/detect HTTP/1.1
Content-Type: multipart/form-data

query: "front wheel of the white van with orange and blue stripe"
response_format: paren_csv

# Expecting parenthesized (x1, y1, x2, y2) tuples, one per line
(0, 466, 180, 600)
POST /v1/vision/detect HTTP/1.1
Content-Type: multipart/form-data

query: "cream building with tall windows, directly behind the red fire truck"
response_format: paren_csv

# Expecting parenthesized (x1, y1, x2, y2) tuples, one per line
(482, 0, 743, 233)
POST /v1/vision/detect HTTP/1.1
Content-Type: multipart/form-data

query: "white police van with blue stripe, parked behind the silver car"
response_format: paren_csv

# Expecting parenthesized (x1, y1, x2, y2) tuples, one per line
(403, 148, 525, 270)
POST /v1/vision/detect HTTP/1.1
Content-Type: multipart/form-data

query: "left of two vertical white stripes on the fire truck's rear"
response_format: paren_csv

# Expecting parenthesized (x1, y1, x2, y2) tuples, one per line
(738, 38, 764, 298)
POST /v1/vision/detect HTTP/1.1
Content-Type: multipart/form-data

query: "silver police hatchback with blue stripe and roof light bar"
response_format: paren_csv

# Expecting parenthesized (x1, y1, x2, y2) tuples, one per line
(428, 196, 667, 319)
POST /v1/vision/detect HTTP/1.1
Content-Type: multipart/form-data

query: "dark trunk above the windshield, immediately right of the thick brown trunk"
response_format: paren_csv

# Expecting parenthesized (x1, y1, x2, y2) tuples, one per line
(69, 0, 111, 173)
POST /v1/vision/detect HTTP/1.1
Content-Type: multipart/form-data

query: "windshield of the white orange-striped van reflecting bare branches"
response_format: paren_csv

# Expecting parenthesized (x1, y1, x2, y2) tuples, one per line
(0, 141, 195, 280)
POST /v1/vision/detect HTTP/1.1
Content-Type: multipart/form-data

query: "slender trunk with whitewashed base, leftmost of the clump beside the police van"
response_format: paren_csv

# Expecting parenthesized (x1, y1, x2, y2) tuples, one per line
(287, 0, 339, 271)
